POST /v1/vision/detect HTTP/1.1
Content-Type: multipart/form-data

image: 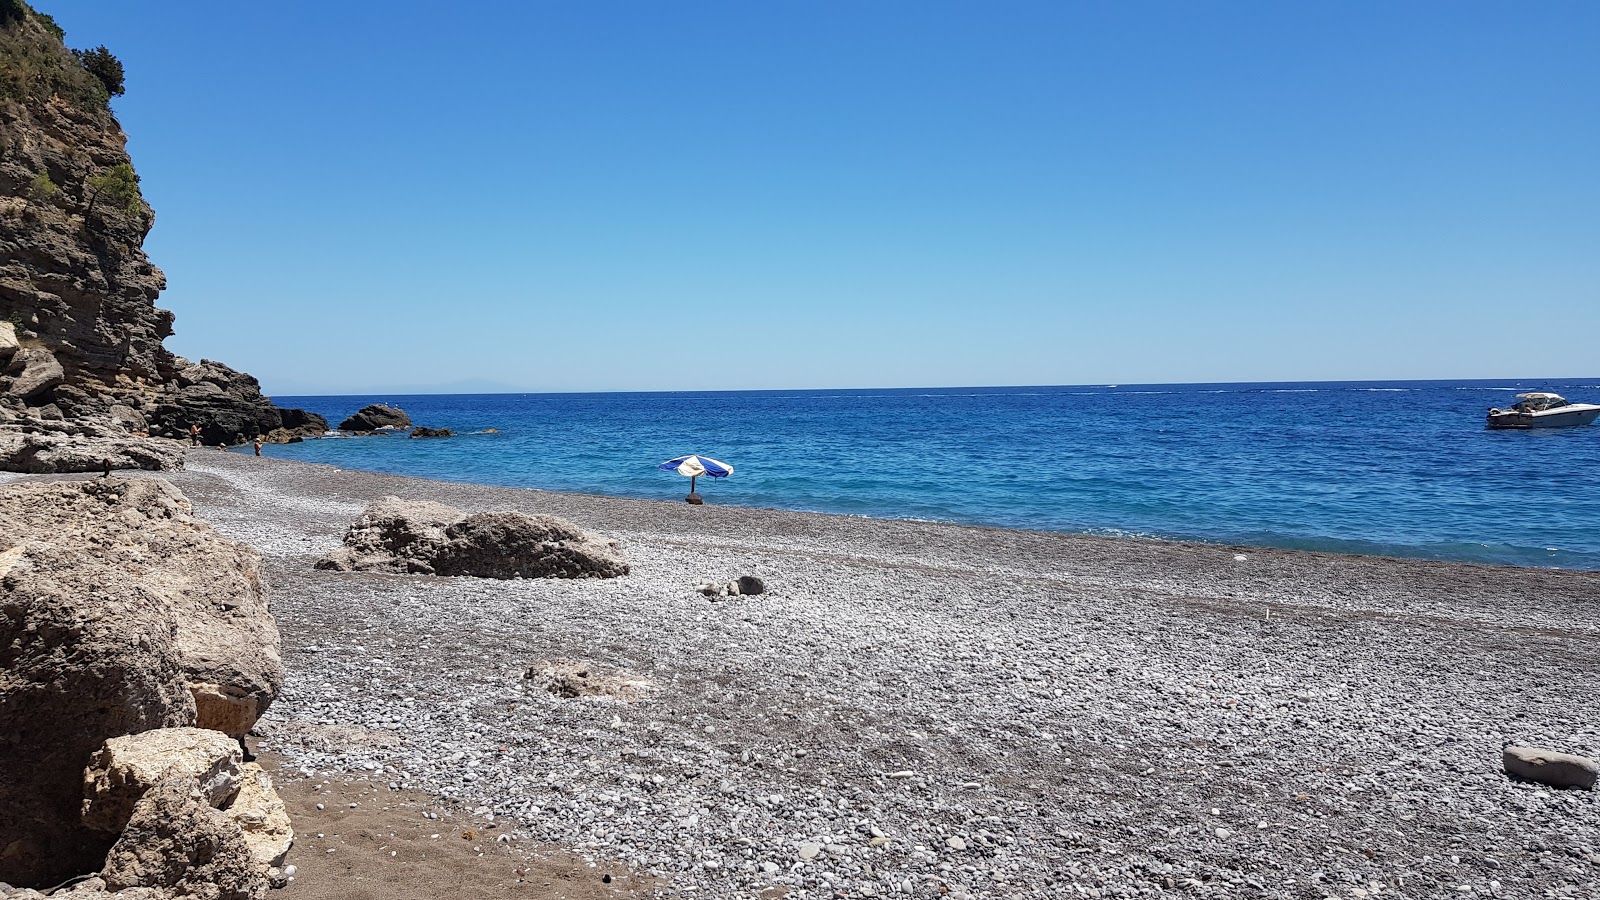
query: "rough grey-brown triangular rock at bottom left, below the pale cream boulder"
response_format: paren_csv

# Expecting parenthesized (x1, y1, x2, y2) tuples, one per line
(101, 777, 267, 900)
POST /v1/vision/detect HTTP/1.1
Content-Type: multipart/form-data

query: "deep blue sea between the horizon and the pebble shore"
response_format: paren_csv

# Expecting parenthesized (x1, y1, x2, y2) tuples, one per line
(266, 378, 1600, 569)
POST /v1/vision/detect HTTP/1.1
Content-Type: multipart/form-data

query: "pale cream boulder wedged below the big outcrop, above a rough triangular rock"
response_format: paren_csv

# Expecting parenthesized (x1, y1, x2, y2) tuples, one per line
(83, 729, 244, 834)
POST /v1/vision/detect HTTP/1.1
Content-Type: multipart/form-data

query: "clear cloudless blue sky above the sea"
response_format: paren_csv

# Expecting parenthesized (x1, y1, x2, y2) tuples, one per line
(35, 0, 1600, 394)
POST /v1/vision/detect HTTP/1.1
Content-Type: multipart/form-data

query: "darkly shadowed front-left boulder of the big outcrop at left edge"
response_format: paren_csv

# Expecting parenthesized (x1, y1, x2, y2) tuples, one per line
(0, 534, 195, 886)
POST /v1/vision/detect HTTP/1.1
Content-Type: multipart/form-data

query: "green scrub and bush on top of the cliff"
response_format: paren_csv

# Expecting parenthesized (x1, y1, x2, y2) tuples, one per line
(0, 0, 123, 112)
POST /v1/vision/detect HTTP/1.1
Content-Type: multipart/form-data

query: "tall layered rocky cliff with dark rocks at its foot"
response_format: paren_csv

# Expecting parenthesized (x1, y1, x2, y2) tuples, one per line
(0, 0, 326, 466)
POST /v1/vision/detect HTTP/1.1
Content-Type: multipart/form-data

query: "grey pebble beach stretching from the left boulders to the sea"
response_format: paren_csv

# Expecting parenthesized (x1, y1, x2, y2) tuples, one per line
(166, 450, 1600, 898)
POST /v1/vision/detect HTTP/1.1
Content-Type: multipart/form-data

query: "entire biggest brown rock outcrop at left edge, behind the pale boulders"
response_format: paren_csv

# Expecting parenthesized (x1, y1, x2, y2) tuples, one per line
(0, 479, 283, 884)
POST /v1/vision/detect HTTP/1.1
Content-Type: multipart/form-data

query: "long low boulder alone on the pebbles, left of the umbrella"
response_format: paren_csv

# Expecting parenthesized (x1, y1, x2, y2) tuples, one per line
(317, 496, 627, 578)
